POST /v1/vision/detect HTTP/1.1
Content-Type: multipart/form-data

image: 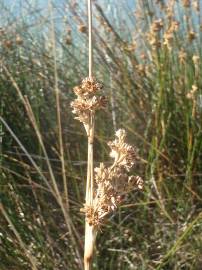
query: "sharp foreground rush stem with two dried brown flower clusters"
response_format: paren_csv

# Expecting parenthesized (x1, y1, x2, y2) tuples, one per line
(71, 0, 143, 270)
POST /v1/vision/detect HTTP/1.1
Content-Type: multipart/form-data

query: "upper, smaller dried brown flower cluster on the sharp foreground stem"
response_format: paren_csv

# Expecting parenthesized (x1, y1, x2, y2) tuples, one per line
(71, 77, 106, 133)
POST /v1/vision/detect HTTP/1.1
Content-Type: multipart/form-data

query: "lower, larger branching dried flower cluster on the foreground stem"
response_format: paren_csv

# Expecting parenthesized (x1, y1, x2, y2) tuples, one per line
(82, 129, 143, 226)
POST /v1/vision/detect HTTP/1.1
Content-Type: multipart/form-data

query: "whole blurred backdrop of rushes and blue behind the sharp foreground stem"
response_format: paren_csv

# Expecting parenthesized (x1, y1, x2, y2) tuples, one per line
(0, 0, 202, 270)
